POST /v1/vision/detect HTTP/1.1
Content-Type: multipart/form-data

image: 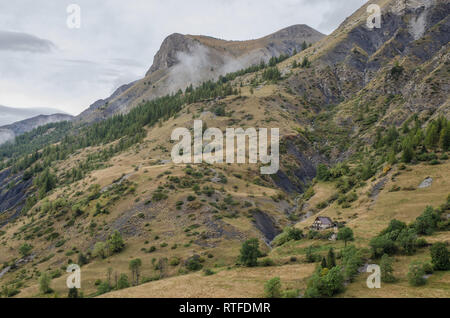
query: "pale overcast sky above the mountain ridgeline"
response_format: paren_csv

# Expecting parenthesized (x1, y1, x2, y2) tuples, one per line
(0, 0, 366, 115)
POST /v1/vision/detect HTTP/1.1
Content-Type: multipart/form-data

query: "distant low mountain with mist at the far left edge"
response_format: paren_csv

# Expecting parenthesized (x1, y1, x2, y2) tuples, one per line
(0, 114, 74, 145)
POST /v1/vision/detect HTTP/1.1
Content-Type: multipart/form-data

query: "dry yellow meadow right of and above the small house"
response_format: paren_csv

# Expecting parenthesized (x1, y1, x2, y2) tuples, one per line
(296, 160, 450, 243)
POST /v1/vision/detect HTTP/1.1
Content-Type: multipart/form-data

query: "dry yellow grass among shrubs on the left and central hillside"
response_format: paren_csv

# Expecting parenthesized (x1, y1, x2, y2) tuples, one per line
(0, 86, 308, 297)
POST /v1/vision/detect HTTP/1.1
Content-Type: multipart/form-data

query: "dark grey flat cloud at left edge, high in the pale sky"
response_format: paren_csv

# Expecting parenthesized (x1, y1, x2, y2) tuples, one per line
(0, 30, 56, 53)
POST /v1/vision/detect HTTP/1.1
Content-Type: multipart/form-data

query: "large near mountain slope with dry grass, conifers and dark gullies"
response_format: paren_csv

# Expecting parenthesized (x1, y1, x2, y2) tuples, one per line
(0, 0, 450, 297)
